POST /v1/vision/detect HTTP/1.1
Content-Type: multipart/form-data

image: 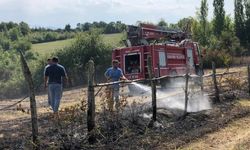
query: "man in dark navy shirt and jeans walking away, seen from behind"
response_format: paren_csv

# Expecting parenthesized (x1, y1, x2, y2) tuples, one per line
(44, 57, 68, 117)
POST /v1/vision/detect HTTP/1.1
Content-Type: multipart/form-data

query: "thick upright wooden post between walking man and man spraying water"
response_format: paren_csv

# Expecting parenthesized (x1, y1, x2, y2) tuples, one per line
(87, 60, 96, 144)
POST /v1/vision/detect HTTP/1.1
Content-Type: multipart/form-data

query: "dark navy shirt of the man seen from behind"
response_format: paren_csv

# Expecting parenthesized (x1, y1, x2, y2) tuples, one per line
(45, 64, 66, 84)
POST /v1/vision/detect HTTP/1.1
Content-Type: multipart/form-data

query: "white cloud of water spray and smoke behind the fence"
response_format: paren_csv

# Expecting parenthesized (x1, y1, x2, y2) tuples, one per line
(129, 81, 211, 112)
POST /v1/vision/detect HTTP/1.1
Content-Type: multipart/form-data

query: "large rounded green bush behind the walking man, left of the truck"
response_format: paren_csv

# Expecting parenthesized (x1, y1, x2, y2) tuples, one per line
(33, 29, 111, 86)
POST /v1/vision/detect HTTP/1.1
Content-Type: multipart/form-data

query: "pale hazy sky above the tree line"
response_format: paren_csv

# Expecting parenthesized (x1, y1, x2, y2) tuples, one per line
(0, 0, 234, 28)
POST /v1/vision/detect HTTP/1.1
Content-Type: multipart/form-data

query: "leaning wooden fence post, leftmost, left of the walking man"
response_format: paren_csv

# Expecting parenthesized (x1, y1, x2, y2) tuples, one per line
(19, 50, 39, 149)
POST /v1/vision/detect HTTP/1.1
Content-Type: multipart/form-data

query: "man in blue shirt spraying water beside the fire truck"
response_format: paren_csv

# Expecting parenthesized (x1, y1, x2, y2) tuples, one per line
(104, 60, 127, 111)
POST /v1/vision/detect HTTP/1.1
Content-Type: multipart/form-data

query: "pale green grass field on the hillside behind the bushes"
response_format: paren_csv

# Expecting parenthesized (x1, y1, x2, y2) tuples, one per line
(31, 33, 123, 55)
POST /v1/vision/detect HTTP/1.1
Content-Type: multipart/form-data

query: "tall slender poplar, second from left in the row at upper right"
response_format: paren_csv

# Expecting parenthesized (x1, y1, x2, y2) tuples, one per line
(213, 0, 225, 37)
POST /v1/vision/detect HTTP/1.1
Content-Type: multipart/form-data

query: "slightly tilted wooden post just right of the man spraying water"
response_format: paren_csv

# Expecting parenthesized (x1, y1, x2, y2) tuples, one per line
(147, 57, 156, 122)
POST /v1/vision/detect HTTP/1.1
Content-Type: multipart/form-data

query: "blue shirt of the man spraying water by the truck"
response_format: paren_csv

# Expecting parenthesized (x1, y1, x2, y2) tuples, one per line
(105, 67, 123, 87)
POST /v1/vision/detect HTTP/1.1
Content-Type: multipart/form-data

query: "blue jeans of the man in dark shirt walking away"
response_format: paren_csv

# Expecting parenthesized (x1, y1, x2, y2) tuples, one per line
(48, 84, 62, 112)
